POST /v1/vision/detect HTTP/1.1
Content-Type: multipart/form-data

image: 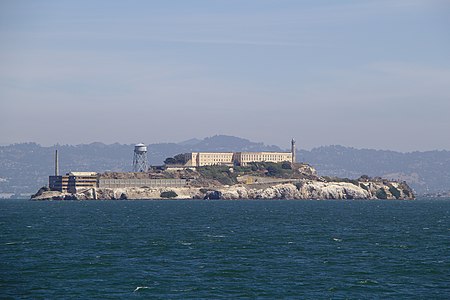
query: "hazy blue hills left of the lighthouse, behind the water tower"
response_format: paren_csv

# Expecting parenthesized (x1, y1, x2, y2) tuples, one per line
(0, 135, 281, 194)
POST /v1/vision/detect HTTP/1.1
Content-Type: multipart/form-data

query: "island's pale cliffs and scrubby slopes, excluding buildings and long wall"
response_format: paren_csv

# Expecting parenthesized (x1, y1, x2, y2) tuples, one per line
(32, 162, 414, 200)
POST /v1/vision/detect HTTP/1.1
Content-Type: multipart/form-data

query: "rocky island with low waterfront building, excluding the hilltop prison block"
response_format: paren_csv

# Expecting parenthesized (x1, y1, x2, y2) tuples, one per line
(32, 162, 415, 200)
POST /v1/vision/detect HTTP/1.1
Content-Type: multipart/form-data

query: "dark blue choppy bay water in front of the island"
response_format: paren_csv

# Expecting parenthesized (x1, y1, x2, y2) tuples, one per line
(0, 199, 450, 299)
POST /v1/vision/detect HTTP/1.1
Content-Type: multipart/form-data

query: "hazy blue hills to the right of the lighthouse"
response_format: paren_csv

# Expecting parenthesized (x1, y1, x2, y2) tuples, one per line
(297, 146, 450, 194)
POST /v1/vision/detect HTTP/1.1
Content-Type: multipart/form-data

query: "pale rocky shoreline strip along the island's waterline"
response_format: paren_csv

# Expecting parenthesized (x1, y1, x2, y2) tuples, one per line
(32, 180, 415, 200)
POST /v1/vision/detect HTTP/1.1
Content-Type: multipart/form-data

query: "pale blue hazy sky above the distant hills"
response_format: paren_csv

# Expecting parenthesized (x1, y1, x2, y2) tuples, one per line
(0, 0, 450, 152)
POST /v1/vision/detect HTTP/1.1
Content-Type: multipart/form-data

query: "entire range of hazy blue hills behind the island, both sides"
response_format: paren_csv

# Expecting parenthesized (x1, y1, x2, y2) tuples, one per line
(0, 135, 450, 196)
